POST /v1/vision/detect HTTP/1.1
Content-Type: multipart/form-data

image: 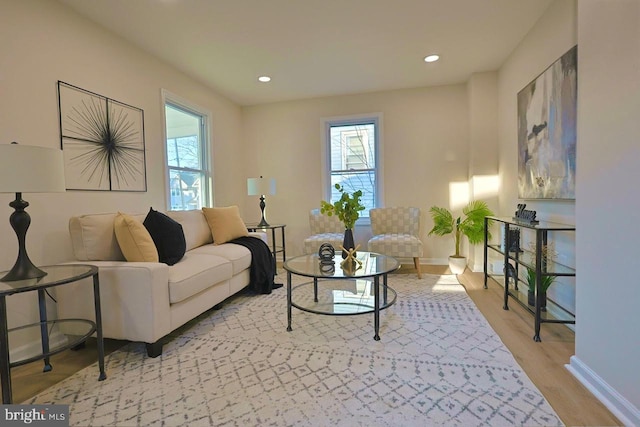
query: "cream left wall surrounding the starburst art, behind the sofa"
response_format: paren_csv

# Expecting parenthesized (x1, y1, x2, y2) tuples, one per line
(0, 0, 246, 349)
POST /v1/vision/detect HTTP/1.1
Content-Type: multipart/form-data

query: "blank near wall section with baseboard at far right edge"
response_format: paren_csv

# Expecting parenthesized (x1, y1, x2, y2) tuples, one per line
(571, 0, 640, 425)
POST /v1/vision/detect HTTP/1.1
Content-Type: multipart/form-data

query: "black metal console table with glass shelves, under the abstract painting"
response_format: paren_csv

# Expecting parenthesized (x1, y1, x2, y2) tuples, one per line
(484, 216, 576, 342)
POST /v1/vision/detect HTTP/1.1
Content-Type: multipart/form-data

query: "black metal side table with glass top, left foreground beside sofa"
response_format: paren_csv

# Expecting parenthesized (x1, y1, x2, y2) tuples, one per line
(0, 264, 107, 404)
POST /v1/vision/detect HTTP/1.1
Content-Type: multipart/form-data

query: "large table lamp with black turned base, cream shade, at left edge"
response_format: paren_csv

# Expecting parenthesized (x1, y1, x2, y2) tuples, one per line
(0, 142, 65, 282)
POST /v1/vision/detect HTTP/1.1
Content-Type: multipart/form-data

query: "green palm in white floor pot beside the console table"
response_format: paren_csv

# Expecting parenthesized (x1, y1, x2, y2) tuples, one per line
(429, 200, 493, 274)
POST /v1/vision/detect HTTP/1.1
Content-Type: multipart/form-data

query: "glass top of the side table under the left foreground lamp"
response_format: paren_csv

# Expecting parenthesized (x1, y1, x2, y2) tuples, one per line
(0, 264, 98, 295)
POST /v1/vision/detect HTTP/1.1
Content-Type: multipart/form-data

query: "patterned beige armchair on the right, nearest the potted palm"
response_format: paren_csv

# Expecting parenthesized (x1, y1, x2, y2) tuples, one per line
(368, 207, 422, 278)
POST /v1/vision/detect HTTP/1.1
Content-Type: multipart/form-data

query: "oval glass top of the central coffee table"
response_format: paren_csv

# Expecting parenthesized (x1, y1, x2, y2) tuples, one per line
(284, 251, 400, 279)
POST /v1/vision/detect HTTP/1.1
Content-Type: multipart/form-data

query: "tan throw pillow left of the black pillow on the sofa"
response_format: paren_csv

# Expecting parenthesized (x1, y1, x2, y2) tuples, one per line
(113, 212, 159, 262)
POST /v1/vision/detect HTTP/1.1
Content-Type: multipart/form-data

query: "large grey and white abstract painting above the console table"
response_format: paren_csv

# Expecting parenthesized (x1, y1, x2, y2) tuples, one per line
(518, 46, 578, 200)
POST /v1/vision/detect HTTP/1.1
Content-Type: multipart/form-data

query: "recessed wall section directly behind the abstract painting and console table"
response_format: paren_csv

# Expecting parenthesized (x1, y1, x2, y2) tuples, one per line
(498, 0, 582, 314)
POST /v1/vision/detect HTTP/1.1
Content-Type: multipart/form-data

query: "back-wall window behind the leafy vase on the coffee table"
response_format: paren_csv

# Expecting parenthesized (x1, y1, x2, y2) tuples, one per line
(325, 115, 381, 218)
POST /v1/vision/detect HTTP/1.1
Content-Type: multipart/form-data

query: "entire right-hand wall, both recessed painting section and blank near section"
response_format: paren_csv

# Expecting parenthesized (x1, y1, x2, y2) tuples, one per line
(498, 0, 640, 425)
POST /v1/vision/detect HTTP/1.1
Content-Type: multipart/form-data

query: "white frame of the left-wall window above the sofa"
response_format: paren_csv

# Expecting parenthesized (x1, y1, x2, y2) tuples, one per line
(161, 89, 214, 210)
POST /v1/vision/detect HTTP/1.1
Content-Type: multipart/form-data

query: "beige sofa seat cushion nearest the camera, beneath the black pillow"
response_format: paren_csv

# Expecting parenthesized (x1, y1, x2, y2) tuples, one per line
(169, 251, 233, 304)
